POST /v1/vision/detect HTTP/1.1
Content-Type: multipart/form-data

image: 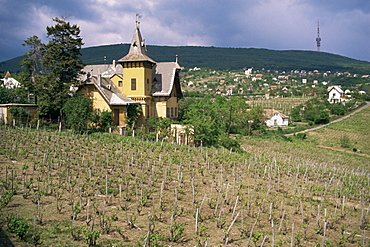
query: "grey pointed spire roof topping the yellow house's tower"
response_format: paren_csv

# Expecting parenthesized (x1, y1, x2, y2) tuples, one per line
(118, 21, 155, 63)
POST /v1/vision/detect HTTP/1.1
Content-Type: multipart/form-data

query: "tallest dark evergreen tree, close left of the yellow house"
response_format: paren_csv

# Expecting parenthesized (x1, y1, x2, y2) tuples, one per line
(37, 18, 83, 117)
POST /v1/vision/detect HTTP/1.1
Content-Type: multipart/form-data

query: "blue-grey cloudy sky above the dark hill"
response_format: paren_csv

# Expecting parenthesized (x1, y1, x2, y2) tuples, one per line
(0, 0, 370, 61)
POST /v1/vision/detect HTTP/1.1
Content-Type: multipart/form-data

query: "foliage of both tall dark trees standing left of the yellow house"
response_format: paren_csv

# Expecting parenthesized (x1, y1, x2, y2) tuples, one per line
(23, 18, 83, 117)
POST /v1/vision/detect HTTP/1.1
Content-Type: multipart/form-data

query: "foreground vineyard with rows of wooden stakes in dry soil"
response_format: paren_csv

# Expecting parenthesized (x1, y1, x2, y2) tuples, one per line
(0, 125, 370, 246)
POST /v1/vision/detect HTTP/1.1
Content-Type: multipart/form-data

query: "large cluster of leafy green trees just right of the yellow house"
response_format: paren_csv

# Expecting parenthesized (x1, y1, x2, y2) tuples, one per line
(180, 96, 263, 145)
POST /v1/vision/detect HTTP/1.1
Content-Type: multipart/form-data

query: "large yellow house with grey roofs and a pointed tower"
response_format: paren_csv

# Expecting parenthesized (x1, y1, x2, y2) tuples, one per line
(79, 21, 183, 126)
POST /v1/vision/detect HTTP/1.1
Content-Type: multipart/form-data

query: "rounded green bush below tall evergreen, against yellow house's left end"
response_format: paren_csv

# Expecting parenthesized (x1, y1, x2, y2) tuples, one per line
(62, 94, 93, 131)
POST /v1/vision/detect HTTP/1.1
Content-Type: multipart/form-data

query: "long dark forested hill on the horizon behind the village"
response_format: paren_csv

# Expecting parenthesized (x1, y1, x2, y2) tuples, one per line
(0, 44, 370, 74)
